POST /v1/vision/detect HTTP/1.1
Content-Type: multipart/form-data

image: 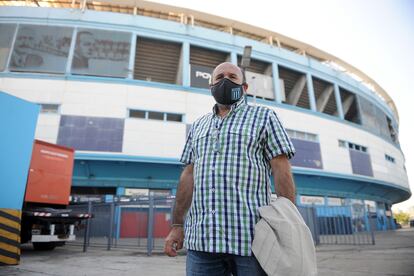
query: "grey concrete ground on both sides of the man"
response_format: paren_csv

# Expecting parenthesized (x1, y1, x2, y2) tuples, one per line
(0, 229, 414, 276)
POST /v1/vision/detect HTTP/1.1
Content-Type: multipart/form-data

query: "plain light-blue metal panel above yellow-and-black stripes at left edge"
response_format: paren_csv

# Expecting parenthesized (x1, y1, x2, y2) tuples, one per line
(0, 92, 40, 210)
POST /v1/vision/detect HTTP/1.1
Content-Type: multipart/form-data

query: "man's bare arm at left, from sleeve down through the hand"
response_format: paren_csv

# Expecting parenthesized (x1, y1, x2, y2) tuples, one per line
(164, 164, 194, 257)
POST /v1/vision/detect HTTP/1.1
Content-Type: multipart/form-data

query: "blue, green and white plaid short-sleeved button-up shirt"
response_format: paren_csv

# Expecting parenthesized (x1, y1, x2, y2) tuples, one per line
(181, 99, 295, 256)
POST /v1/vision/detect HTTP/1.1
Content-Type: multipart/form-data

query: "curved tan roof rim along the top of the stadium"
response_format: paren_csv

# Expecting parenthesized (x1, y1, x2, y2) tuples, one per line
(0, 0, 399, 121)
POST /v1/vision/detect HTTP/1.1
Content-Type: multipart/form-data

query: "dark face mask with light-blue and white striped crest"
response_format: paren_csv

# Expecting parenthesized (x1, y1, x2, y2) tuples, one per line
(210, 78, 243, 105)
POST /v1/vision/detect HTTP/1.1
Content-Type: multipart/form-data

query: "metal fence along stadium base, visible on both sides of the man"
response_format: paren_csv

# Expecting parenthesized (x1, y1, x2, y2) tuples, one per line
(69, 196, 375, 255)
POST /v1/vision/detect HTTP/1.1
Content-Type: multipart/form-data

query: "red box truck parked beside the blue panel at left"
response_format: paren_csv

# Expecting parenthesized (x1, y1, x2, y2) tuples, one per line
(21, 140, 90, 250)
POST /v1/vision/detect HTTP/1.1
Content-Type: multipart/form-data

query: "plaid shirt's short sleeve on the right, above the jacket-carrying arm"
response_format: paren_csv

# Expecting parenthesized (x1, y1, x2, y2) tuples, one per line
(264, 110, 295, 160)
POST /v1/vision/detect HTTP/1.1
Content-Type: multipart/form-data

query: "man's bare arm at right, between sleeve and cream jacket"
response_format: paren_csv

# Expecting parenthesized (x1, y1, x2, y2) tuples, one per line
(270, 155, 296, 204)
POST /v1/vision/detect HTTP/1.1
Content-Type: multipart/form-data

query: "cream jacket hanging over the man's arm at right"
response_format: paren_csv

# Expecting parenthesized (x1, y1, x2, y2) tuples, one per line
(252, 197, 318, 276)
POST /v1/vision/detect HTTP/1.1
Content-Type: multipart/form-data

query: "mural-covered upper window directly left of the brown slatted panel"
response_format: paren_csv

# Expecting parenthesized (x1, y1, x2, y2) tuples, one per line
(72, 28, 131, 77)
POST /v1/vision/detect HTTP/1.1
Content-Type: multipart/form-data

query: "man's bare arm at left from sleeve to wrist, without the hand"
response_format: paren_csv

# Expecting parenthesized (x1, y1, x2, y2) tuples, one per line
(172, 165, 194, 224)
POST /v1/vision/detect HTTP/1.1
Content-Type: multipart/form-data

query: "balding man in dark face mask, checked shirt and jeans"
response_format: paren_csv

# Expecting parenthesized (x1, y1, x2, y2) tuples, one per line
(165, 62, 295, 276)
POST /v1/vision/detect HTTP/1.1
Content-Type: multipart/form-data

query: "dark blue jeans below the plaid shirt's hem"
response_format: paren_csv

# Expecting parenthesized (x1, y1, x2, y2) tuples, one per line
(186, 250, 266, 276)
